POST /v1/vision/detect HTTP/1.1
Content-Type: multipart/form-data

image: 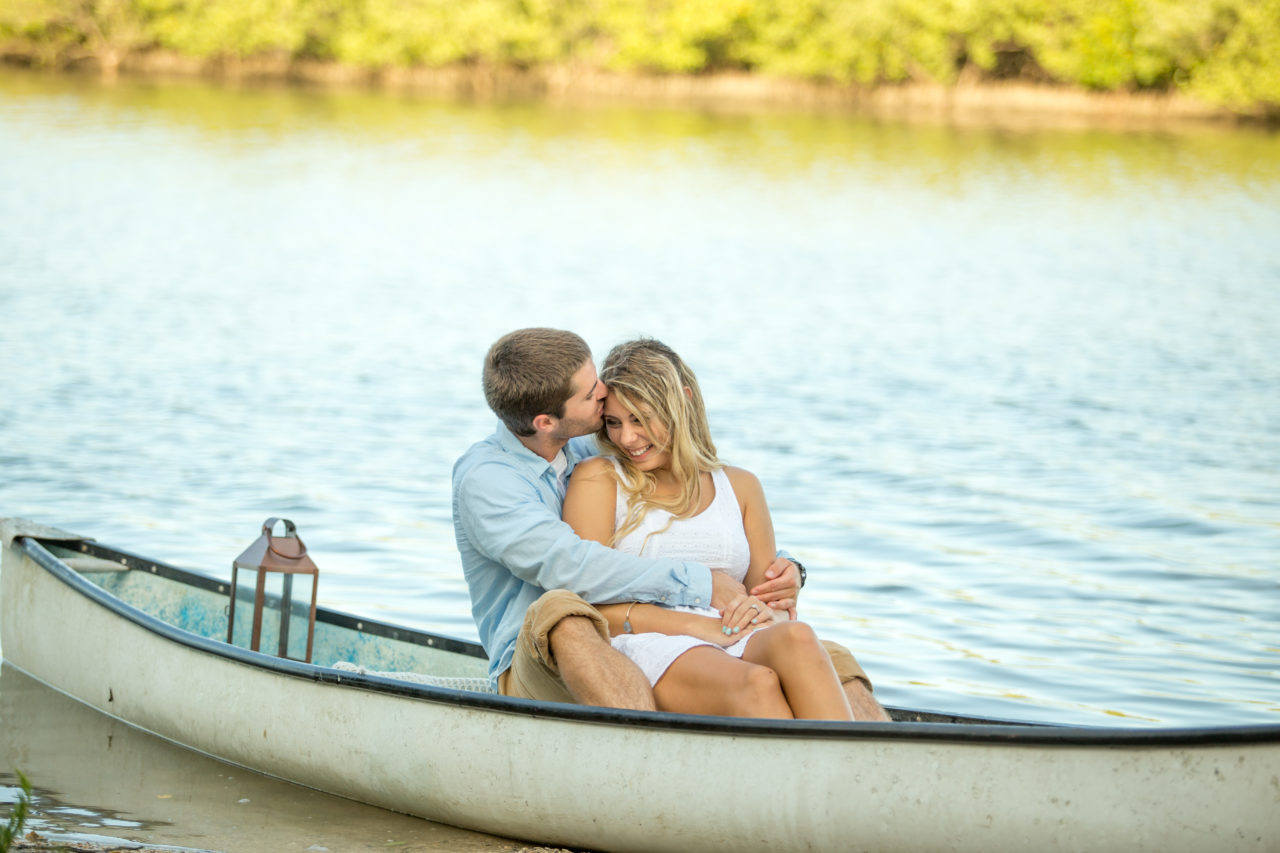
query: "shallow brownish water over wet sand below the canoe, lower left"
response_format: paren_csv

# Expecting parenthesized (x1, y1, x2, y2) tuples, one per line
(0, 661, 573, 853)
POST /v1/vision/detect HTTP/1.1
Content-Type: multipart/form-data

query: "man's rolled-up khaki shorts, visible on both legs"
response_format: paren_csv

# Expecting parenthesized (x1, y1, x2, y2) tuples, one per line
(498, 589, 873, 702)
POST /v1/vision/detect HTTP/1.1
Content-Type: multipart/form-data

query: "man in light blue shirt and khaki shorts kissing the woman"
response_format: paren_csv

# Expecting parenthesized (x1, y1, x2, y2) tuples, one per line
(453, 329, 887, 720)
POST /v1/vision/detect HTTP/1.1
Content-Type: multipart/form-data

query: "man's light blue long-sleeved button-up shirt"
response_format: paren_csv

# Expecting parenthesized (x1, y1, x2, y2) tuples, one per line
(453, 423, 712, 680)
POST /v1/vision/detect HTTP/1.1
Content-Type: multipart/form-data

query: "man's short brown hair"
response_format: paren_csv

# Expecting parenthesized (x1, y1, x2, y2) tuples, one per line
(484, 329, 591, 435)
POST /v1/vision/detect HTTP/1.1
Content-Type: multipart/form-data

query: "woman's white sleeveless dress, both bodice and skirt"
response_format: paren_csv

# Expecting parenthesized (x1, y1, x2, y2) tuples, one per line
(611, 460, 751, 684)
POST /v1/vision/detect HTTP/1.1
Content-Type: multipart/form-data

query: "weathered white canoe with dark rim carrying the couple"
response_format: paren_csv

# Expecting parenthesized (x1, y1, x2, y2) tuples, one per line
(0, 525, 1280, 853)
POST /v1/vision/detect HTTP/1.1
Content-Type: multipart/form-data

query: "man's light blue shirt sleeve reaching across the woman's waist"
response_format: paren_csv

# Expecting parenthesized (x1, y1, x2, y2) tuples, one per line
(454, 462, 716, 606)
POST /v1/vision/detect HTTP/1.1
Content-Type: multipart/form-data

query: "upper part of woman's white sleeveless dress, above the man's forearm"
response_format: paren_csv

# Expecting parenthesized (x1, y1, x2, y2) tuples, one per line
(609, 457, 751, 583)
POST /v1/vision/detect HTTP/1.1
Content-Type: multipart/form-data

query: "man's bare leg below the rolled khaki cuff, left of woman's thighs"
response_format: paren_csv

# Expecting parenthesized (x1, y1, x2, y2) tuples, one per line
(548, 616, 657, 711)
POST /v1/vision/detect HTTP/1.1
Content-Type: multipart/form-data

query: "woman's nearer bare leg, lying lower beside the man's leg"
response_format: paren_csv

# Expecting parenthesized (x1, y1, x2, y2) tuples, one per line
(653, 646, 792, 720)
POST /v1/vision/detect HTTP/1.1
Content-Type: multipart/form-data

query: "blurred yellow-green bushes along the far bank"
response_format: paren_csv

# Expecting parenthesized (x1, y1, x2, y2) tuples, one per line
(0, 0, 1280, 118)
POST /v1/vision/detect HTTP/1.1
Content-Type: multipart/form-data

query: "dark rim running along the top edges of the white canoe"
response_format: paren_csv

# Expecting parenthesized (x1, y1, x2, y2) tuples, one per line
(13, 537, 1280, 749)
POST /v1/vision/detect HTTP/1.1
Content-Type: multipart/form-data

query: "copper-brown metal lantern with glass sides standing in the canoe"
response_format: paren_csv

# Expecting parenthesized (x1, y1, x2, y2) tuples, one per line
(227, 519, 320, 663)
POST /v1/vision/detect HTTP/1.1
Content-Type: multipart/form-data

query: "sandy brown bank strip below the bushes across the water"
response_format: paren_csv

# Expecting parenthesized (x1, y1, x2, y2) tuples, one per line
(0, 51, 1261, 129)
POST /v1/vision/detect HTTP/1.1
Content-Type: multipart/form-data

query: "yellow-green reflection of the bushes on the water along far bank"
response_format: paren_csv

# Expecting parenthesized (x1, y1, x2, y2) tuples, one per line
(0, 70, 1280, 197)
